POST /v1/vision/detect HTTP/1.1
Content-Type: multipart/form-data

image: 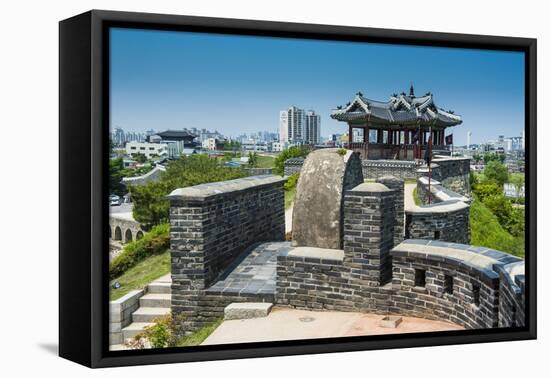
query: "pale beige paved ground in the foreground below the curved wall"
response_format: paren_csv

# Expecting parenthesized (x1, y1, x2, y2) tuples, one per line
(201, 308, 464, 345)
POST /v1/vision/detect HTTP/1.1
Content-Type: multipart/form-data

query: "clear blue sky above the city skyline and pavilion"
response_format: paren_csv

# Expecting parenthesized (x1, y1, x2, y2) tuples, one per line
(111, 29, 524, 145)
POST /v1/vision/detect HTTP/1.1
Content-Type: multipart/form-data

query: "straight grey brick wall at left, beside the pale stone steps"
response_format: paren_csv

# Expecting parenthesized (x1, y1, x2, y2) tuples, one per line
(168, 176, 285, 327)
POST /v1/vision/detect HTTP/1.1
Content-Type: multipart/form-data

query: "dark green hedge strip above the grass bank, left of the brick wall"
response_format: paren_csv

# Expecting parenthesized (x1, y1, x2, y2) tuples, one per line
(109, 224, 170, 280)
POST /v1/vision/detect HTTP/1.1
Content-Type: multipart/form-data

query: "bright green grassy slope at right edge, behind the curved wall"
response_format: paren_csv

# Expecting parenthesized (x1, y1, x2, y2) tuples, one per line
(470, 199, 525, 258)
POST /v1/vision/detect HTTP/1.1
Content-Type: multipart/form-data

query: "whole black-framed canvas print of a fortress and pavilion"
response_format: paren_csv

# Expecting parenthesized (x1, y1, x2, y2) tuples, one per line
(59, 11, 536, 367)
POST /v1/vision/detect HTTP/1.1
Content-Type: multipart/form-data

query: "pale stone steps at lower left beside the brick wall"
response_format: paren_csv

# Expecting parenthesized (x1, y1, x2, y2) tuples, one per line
(110, 274, 172, 350)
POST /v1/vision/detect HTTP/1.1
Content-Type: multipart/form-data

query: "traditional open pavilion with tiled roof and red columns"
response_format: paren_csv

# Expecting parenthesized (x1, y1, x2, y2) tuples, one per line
(330, 85, 462, 160)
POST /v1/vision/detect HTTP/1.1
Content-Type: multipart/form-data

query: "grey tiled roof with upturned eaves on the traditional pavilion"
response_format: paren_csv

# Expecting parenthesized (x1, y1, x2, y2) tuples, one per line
(330, 90, 462, 127)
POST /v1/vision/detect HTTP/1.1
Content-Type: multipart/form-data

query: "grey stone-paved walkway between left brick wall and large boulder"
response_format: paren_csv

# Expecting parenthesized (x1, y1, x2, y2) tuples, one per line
(207, 242, 291, 296)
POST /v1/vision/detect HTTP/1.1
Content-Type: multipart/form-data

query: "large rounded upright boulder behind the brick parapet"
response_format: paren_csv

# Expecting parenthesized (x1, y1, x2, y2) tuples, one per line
(292, 148, 364, 249)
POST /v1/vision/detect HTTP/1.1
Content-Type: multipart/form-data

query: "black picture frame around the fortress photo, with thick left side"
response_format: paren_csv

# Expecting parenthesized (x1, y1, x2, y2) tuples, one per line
(59, 10, 537, 368)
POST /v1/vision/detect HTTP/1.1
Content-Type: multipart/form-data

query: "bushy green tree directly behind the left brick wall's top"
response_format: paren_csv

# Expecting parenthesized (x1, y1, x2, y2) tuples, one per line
(129, 154, 246, 227)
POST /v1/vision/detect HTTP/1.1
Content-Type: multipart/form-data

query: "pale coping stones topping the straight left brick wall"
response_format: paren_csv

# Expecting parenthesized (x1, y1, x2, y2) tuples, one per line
(166, 175, 287, 201)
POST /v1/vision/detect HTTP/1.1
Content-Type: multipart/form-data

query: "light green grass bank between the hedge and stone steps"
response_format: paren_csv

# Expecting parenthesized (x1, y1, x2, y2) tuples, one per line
(110, 250, 170, 300)
